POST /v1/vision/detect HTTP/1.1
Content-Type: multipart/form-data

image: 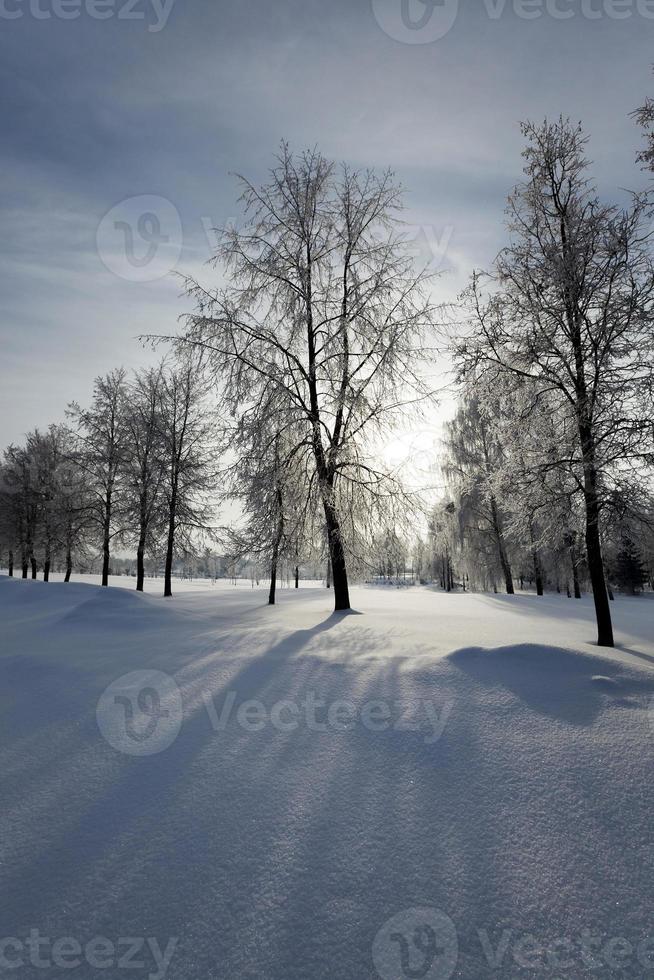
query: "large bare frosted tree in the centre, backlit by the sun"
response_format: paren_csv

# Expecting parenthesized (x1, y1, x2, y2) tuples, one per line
(177, 145, 438, 609)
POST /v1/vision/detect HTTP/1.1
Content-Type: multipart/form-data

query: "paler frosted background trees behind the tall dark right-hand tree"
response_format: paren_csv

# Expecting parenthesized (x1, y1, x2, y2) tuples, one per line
(428, 386, 654, 598)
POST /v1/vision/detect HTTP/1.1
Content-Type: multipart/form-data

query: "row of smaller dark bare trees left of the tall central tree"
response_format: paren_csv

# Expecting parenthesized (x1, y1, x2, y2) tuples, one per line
(0, 359, 216, 595)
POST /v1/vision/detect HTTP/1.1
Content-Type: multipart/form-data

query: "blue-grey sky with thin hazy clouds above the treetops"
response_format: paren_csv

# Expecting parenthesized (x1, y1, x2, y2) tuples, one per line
(0, 0, 654, 446)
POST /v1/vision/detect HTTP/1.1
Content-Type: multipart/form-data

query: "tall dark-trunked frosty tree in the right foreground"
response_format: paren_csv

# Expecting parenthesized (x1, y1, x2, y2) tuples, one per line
(458, 119, 654, 646)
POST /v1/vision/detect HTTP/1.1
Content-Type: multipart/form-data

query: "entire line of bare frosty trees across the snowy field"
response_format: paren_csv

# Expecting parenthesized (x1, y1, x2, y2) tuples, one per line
(0, 84, 654, 645)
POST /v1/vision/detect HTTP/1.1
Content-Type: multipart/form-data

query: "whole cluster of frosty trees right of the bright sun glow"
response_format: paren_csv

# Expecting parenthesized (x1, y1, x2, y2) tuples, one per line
(436, 105, 654, 646)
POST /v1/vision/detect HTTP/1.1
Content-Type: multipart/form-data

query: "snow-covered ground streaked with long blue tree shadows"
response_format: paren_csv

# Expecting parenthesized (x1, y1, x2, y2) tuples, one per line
(0, 577, 654, 980)
